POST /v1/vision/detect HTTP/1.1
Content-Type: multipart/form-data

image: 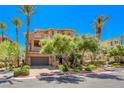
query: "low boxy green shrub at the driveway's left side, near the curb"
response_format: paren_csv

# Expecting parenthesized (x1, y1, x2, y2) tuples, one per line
(14, 65, 30, 77)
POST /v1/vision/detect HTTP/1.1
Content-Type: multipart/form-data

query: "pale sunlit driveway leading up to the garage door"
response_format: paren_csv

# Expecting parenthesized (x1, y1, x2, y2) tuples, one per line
(30, 66, 61, 76)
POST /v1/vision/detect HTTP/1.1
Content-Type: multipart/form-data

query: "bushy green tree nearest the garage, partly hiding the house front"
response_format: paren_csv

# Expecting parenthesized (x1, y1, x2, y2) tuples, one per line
(40, 34, 72, 64)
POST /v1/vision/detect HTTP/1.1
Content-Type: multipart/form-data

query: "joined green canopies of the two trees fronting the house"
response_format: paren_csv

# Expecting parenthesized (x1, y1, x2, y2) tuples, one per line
(40, 34, 98, 63)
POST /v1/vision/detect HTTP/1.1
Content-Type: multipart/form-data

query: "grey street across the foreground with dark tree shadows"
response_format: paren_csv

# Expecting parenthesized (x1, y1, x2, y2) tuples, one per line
(0, 68, 124, 88)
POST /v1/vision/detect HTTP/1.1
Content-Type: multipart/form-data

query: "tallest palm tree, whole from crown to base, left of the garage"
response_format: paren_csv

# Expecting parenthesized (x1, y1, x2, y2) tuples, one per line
(19, 5, 35, 63)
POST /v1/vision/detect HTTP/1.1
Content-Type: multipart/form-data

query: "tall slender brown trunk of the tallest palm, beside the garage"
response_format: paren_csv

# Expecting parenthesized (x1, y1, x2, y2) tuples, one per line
(25, 16, 30, 64)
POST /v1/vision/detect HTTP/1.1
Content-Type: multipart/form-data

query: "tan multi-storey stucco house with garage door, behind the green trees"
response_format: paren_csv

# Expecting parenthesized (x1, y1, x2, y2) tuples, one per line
(25, 29, 73, 66)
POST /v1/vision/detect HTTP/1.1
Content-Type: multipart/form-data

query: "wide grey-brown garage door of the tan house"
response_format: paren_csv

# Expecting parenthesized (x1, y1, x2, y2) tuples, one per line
(31, 57, 49, 66)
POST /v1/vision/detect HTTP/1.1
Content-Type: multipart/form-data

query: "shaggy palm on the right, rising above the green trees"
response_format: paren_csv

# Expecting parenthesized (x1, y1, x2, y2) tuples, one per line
(93, 15, 110, 39)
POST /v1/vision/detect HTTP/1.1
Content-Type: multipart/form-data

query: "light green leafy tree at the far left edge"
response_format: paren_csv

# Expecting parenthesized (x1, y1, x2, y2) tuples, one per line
(0, 41, 20, 68)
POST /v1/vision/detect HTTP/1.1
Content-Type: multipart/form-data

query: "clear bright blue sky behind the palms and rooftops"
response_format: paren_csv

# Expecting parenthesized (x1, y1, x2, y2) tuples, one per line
(0, 5, 124, 46)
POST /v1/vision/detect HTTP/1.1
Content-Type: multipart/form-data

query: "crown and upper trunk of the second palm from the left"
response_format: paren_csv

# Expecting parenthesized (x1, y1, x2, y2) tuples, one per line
(10, 17, 21, 44)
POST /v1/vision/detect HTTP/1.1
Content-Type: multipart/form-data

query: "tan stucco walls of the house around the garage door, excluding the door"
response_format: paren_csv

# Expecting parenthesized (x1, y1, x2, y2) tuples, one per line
(24, 29, 74, 66)
